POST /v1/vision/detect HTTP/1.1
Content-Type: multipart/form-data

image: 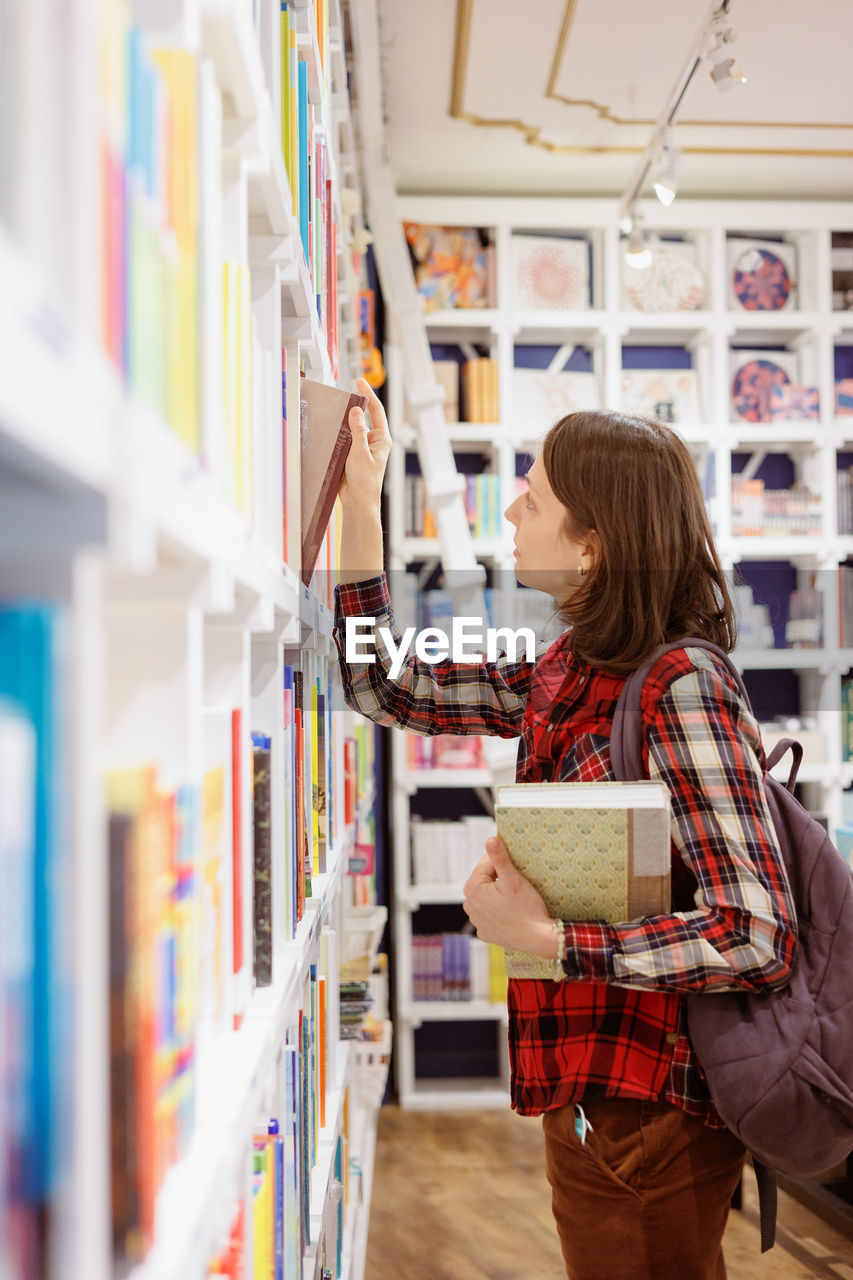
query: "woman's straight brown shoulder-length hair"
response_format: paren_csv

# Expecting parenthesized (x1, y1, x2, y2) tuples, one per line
(542, 410, 735, 672)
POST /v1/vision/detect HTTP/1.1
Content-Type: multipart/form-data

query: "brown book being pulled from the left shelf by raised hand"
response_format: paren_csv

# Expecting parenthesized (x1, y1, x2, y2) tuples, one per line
(300, 378, 368, 586)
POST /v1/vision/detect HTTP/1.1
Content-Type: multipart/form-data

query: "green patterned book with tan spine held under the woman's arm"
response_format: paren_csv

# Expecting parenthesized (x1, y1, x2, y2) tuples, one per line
(494, 782, 671, 978)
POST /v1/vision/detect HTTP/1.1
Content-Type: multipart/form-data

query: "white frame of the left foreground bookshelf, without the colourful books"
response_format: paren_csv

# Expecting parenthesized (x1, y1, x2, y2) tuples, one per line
(0, 0, 384, 1280)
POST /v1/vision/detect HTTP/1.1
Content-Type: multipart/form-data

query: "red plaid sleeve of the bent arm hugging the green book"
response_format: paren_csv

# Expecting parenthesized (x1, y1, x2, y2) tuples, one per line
(565, 649, 797, 992)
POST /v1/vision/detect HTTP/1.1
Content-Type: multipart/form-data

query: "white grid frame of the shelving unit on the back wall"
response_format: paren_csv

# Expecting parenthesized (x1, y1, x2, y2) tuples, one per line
(387, 196, 853, 1107)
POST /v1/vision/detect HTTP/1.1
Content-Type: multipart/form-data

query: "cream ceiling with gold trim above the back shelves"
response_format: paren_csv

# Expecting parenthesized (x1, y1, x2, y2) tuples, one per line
(376, 0, 853, 200)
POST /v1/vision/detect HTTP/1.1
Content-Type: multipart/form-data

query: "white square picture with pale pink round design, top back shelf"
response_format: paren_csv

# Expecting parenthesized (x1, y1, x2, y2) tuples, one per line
(511, 236, 589, 311)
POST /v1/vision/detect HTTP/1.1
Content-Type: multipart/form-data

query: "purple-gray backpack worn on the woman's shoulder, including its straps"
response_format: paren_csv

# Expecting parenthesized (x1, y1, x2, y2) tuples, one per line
(610, 639, 853, 1252)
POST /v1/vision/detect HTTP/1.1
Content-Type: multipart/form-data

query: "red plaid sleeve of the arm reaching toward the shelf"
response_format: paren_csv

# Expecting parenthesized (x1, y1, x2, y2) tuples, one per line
(334, 573, 533, 737)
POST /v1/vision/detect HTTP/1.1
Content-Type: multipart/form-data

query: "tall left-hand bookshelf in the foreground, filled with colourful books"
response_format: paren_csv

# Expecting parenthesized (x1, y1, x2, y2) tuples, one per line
(0, 0, 389, 1280)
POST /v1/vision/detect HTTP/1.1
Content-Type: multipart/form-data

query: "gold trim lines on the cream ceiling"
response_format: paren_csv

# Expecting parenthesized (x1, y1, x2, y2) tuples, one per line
(450, 0, 853, 159)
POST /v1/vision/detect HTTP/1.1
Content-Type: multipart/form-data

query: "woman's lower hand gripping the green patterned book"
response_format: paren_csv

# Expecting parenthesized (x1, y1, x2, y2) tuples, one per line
(462, 836, 558, 960)
